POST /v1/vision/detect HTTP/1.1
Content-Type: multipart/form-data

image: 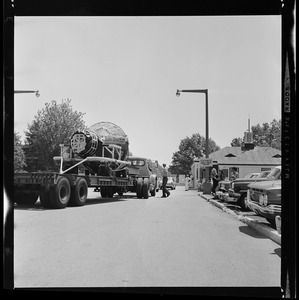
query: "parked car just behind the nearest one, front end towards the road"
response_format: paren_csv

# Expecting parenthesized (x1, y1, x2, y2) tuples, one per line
(216, 166, 281, 209)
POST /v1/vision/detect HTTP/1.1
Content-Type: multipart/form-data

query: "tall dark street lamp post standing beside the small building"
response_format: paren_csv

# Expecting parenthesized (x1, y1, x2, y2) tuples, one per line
(176, 89, 211, 194)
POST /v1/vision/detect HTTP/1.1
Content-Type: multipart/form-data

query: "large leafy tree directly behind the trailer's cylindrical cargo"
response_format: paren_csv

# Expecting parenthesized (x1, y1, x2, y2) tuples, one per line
(23, 99, 86, 171)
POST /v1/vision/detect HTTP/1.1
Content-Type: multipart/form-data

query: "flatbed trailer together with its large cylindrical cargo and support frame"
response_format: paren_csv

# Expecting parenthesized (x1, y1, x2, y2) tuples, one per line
(14, 122, 148, 208)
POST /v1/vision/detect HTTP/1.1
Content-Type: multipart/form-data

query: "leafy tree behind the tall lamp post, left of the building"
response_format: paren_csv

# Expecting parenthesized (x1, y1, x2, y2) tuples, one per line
(169, 133, 220, 174)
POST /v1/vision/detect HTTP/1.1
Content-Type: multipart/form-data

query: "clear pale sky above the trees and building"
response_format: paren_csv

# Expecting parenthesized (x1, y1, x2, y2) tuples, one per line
(14, 15, 281, 165)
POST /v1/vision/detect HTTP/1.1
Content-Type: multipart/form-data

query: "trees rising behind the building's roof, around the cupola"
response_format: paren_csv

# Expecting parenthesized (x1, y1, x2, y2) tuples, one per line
(231, 119, 281, 150)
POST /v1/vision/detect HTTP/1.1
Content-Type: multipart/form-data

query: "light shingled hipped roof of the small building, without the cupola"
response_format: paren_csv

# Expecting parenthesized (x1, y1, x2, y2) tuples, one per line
(209, 146, 281, 165)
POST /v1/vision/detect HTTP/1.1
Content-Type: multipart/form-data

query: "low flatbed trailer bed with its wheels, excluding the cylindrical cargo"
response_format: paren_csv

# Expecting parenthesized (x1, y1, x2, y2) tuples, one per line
(14, 169, 138, 208)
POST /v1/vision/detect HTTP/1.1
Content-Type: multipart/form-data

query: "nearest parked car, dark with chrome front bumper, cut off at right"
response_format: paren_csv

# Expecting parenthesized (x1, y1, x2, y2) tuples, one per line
(245, 176, 281, 228)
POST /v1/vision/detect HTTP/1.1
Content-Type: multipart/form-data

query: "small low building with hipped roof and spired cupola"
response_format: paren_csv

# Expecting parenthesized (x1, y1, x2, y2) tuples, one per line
(191, 132, 281, 187)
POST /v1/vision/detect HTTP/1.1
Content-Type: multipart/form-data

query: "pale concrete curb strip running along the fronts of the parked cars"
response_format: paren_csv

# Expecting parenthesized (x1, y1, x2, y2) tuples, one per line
(198, 192, 281, 245)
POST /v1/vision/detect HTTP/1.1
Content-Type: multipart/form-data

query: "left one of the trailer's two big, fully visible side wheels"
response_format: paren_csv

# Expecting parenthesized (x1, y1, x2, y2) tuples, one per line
(50, 177, 71, 208)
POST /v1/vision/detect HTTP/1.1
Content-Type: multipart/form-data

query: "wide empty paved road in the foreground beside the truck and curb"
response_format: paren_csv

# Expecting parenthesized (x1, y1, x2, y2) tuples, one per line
(14, 187, 281, 287)
